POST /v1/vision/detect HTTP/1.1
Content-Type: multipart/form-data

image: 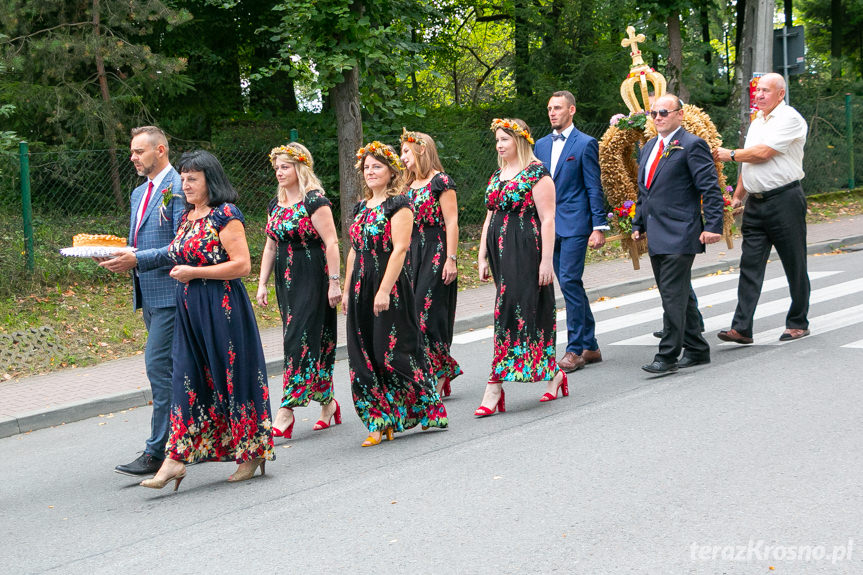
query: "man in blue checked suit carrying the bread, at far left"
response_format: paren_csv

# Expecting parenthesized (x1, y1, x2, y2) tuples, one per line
(99, 126, 185, 475)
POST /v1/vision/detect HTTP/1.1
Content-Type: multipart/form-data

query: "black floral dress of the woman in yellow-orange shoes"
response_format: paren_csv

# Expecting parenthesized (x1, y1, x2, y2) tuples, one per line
(345, 195, 447, 432)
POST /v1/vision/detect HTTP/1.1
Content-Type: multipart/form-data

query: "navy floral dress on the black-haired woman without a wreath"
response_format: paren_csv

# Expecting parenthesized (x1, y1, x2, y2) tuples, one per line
(165, 203, 275, 463)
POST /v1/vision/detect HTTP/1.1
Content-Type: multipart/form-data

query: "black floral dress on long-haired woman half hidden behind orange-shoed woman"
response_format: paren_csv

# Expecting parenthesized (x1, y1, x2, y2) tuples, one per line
(406, 172, 462, 380)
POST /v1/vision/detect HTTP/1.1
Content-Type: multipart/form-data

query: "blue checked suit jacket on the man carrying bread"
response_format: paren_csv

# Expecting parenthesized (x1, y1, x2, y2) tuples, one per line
(129, 168, 186, 309)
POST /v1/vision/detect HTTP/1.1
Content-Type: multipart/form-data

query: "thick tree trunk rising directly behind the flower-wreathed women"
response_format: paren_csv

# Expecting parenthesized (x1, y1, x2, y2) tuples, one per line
(331, 67, 363, 254)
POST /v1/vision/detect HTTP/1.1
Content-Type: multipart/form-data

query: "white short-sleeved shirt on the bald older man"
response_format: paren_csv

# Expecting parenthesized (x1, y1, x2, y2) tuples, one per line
(740, 100, 807, 194)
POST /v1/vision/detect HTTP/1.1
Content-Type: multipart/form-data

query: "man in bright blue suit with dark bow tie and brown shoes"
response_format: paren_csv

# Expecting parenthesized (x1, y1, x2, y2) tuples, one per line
(534, 90, 608, 372)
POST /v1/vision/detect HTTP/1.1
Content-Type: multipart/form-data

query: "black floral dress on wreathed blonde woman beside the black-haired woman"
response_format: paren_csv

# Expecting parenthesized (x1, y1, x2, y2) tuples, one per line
(266, 190, 338, 408)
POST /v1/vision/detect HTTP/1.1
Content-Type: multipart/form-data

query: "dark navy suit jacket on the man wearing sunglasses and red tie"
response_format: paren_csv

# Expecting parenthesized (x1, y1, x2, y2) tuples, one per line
(632, 132, 724, 255)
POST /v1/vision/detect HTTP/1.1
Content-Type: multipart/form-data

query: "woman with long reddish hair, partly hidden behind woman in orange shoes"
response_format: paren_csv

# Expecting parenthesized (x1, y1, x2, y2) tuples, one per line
(401, 129, 462, 396)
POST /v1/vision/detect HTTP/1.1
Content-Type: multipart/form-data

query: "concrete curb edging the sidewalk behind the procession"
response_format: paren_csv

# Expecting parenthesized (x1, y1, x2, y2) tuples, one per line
(8, 234, 863, 438)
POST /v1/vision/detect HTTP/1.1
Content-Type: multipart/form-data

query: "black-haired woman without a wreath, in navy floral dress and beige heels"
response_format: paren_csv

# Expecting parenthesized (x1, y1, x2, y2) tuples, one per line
(141, 150, 275, 491)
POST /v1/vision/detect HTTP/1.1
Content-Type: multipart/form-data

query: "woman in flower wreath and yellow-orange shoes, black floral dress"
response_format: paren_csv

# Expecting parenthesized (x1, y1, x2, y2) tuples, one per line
(342, 142, 447, 447)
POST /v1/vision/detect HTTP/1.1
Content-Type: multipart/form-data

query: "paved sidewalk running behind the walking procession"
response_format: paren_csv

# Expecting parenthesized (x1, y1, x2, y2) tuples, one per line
(0, 216, 863, 437)
